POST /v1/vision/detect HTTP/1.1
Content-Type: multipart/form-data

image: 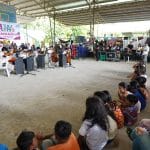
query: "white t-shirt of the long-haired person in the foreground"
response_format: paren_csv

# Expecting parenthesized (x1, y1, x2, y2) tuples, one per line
(79, 120, 108, 150)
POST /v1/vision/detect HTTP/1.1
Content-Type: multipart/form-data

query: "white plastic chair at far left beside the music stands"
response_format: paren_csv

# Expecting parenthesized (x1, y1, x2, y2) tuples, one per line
(0, 57, 10, 77)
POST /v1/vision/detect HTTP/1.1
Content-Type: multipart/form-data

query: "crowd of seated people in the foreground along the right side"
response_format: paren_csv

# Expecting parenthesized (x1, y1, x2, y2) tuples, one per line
(0, 54, 150, 150)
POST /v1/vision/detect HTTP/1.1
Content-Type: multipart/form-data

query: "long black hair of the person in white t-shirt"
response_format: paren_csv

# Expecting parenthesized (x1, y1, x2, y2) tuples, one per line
(83, 96, 109, 131)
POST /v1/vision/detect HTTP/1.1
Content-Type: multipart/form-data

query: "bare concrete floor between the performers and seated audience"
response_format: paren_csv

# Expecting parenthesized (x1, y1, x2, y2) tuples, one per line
(0, 59, 150, 150)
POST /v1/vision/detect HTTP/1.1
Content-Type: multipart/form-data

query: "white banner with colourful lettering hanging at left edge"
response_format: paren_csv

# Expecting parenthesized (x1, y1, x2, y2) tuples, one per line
(0, 21, 20, 40)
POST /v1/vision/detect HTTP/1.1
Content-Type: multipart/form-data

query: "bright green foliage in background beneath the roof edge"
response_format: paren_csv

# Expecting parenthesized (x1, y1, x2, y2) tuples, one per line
(28, 17, 89, 43)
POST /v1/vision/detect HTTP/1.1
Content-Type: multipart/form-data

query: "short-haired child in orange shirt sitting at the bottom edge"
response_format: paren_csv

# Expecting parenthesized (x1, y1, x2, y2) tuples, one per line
(41, 120, 80, 150)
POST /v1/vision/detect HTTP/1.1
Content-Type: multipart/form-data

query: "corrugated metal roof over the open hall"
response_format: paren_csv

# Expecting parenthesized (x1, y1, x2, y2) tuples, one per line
(0, 0, 150, 25)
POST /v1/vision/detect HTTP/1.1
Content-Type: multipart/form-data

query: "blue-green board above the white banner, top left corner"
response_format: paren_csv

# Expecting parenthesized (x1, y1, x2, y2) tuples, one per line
(0, 3, 16, 23)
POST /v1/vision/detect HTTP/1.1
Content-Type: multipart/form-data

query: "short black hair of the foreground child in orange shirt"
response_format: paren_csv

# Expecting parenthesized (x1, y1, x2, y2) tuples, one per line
(55, 120, 72, 140)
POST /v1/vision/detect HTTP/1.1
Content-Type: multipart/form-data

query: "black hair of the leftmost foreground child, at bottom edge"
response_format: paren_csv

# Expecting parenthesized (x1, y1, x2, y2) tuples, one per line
(16, 131, 35, 150)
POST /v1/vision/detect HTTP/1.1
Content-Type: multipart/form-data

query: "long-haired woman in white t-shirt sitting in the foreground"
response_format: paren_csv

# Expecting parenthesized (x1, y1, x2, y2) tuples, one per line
(78, 96, 109, 150)
